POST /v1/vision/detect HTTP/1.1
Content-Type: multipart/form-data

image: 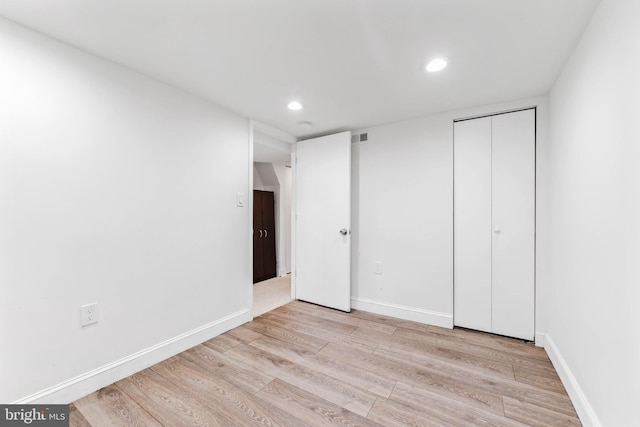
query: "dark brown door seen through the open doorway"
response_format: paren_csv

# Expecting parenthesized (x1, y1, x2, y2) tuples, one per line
(253, 190, 276, 283)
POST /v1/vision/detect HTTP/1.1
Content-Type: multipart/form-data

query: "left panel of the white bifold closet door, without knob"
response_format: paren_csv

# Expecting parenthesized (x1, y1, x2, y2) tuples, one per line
(453, 117, 491, 332)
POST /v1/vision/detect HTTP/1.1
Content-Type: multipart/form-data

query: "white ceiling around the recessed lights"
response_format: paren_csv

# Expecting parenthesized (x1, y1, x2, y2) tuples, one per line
(0, 0, 599, 137)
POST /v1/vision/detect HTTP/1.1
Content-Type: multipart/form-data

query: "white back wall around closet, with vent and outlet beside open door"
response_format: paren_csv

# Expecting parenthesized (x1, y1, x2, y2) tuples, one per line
(352, 97, 548, 330)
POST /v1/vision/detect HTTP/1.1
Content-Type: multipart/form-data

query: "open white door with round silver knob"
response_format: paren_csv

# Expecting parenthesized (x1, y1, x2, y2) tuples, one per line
(294, 132, 351, 311)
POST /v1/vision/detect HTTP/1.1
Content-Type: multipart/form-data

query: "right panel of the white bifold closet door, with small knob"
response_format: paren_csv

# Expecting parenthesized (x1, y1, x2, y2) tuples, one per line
(491, 110, 535, 340)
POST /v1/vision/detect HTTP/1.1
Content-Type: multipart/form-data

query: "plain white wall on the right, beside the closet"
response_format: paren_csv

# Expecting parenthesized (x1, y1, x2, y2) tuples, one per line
(544, 0, 640, 427)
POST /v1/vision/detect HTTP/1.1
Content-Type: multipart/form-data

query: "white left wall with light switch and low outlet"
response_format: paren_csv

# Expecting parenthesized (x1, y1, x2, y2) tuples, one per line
(0, 20, 251, 403)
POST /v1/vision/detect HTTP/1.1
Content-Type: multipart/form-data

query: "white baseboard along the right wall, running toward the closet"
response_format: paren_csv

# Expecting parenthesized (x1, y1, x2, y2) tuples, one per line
(536, 334, 602, 427)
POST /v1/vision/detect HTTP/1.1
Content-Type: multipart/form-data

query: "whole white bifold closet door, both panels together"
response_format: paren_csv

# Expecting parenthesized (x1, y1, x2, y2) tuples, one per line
(454, 109, 535, 340)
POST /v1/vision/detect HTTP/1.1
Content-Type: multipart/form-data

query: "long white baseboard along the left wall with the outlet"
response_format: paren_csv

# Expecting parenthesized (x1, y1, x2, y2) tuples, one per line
(13, 309, 252, 404)
